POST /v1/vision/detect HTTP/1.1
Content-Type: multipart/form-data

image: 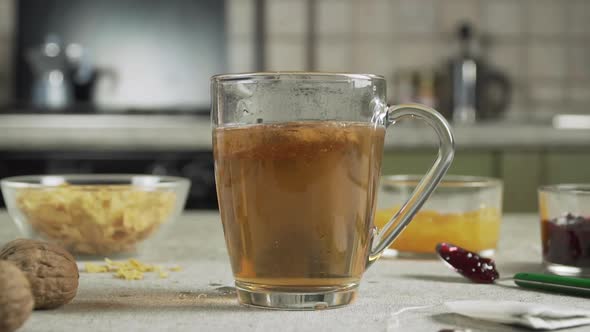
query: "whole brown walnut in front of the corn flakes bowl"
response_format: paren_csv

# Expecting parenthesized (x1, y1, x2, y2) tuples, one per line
(0, 239, 79, 309)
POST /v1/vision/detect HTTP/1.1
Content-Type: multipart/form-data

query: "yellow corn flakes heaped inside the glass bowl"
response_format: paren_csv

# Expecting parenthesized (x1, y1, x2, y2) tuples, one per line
(16, 185, 176, 255)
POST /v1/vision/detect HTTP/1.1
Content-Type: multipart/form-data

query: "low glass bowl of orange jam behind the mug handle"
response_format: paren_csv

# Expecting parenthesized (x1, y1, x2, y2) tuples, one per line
(375, 175, 502, 257)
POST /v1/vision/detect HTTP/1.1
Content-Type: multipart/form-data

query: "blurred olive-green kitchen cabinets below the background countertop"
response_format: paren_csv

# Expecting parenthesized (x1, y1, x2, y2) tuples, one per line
(382, 148, 590, 212)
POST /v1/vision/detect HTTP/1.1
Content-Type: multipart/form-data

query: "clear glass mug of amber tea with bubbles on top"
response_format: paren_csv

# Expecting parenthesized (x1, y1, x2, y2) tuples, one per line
(211, 72, 454, 310)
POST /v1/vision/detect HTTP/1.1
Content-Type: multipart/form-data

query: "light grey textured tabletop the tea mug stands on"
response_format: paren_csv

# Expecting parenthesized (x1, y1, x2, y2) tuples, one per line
(0, 212, 590, 332)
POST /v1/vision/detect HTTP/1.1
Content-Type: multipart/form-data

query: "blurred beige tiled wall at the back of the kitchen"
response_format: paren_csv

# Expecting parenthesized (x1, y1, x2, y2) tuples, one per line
(0, 0, 590, 112)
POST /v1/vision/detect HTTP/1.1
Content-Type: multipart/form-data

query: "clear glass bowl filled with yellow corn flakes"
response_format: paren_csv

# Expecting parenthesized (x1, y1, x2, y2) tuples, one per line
(0, 174, 190, 256)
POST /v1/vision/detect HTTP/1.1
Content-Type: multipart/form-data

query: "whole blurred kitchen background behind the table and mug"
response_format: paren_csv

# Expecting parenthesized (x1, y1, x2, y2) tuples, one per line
(0, 0, 590, 211)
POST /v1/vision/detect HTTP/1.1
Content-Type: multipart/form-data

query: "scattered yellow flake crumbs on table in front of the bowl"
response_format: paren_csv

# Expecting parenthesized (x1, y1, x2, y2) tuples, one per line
(84, 258, 182, 280)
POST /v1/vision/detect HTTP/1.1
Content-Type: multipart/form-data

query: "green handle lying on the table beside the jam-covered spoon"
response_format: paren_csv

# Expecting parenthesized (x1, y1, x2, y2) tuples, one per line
(514, 273, 590, 296)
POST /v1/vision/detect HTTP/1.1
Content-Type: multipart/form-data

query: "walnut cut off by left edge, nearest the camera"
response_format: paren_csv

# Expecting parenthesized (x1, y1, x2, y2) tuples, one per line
(0, 261, 34, 332)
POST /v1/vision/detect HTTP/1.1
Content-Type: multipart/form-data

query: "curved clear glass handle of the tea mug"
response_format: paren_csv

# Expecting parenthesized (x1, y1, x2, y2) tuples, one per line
(367, 104, 455, 267)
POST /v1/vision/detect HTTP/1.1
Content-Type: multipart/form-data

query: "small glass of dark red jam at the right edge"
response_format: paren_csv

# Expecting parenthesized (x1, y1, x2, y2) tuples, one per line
(539, 184, 590, 277)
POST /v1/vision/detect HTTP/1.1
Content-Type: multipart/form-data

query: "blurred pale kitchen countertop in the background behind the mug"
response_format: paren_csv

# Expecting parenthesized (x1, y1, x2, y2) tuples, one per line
(0, 114, 590, 151)
